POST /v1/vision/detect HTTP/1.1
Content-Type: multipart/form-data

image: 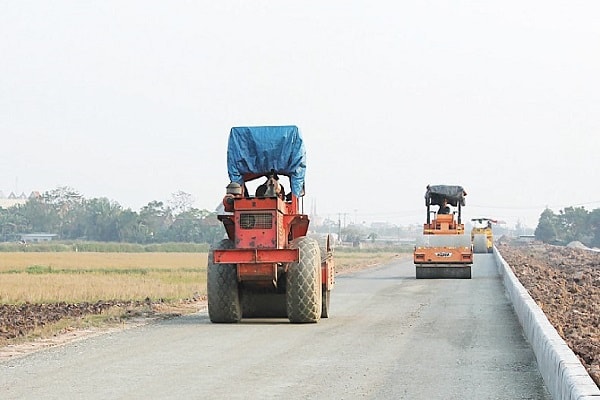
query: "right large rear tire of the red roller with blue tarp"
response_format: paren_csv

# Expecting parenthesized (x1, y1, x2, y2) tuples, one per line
(286, 236, 322, 323)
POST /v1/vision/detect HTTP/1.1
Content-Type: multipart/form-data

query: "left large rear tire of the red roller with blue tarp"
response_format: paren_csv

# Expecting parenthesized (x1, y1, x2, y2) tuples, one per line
(206, 239, 242, 323)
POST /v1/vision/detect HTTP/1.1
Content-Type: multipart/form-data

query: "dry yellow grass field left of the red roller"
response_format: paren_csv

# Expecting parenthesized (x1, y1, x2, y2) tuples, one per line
(0, 252, 207, 304)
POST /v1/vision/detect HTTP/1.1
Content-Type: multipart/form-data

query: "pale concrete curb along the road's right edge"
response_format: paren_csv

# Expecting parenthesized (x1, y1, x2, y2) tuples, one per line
(494, 247, 600, 400)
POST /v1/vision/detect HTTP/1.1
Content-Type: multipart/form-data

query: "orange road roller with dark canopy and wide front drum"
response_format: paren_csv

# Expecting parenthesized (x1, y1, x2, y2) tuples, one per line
(414, 185, 473, 279)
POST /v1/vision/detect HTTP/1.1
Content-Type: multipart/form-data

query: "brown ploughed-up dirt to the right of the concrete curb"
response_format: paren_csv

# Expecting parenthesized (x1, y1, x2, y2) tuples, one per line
(497, 240, 600, 387)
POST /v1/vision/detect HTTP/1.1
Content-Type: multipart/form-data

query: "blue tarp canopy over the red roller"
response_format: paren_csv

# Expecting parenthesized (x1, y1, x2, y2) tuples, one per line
(227, 125, 306, 197)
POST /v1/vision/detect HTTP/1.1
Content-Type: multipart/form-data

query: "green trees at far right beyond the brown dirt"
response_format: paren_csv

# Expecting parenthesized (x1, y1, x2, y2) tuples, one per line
(535, 207, 600, 247)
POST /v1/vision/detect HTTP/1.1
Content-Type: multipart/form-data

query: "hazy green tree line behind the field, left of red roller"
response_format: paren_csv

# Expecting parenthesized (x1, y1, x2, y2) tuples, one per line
(0, 187, 225, 244)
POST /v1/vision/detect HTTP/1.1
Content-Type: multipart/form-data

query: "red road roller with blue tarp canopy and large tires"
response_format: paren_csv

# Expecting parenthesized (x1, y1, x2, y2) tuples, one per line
(207, 126, 335, 323)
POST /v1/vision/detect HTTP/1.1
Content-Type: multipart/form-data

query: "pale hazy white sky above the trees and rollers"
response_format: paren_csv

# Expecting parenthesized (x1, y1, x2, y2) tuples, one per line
(0, 0, 600, 227)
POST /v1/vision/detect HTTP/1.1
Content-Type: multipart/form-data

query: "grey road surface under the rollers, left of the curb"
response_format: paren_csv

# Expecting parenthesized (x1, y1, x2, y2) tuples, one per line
(0, 254, 551, 400)
